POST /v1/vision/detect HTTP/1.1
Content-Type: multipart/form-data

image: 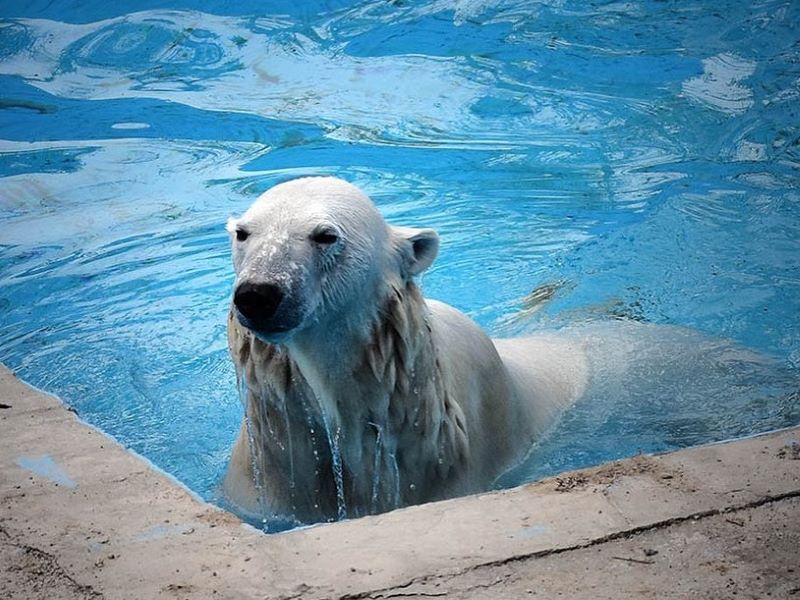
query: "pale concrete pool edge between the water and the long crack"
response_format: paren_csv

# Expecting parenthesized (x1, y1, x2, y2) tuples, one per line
(0, 367, 800, 598)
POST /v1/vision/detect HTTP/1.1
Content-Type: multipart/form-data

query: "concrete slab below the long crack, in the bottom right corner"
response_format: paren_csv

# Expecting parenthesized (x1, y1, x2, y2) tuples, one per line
(347, 494, 800, 600)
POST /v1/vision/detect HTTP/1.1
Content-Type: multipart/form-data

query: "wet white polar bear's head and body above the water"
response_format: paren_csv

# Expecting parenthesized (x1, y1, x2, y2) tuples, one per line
(223, 177, 588, 522)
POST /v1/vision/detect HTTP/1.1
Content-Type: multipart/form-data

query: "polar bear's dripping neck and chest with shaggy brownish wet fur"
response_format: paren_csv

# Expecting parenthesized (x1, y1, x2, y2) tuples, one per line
(229, 281, 468, 518)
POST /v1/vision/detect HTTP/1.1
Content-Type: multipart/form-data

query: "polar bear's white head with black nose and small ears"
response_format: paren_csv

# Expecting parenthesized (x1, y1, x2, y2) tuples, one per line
(227, 177, 439, 343)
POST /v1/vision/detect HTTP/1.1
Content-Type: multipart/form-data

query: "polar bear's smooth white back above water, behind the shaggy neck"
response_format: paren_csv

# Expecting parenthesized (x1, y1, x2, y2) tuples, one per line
(426, 300, 588, 488)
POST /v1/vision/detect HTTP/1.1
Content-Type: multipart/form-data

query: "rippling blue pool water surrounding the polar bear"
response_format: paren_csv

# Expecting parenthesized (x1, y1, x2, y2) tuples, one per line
(0, 0, 800, 524)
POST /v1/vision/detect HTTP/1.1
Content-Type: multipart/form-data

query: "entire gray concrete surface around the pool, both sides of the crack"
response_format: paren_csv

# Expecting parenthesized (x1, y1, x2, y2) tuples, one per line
(0, 368, 800, 600)
